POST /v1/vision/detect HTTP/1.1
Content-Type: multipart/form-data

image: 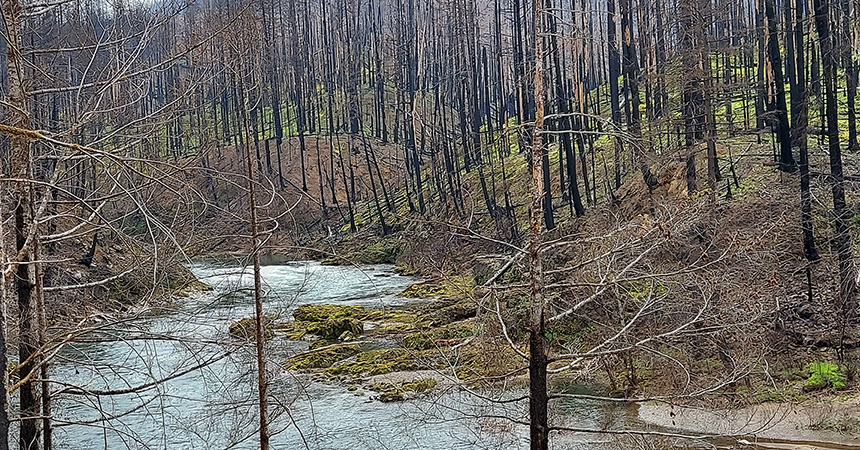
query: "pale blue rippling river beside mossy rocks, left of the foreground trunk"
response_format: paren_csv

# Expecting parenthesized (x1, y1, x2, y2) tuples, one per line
(52, 262, 544, 450)
